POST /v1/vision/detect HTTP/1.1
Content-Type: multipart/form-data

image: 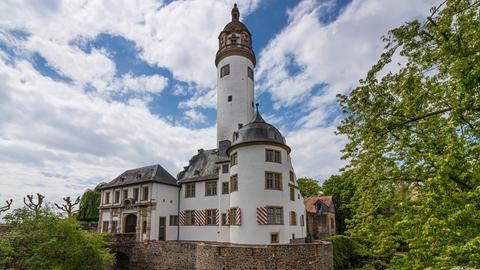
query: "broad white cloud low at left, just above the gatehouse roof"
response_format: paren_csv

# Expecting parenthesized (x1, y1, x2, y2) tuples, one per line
(0, 59, 216, 211)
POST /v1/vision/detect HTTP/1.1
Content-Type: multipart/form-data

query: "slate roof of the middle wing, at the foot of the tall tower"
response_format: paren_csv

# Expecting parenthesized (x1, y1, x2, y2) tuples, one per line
(177, 149, 228, 183)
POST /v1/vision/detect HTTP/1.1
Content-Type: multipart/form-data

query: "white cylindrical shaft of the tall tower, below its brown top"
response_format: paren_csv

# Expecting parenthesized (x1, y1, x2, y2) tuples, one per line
(217, 55, 254, 143)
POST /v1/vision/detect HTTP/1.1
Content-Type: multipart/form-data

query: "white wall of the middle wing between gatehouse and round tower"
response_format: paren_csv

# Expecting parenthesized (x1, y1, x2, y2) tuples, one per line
(180, 181, 221, 241)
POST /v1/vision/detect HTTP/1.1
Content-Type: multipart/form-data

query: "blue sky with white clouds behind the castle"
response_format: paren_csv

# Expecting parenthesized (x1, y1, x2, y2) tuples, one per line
(0, 0, 438, 210)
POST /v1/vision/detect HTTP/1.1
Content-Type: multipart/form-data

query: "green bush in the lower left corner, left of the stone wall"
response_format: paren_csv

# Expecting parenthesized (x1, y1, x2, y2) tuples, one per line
(0, 209, 114, 270)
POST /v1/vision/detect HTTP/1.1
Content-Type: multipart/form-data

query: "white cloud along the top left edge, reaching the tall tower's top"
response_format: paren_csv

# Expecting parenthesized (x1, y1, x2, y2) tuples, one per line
(0, 0, 260, 88)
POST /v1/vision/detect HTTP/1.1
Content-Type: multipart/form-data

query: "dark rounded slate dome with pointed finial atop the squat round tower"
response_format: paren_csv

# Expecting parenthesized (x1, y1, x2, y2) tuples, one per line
(227, 104, 290, 153)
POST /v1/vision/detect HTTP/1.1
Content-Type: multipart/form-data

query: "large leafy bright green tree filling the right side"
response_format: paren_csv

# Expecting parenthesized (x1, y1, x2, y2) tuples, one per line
(339, 0, 480, 269)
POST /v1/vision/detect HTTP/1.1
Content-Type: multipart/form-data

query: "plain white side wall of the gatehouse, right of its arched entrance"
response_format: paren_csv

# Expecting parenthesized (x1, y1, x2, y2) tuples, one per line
(150, 183, 179, 240)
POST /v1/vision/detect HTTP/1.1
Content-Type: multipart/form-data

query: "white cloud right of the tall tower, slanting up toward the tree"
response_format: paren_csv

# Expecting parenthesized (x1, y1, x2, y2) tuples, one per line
(257, 0, 438, 123)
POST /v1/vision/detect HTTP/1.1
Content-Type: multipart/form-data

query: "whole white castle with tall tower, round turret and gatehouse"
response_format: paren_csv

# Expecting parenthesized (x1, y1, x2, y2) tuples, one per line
(99, 5, 306, 245)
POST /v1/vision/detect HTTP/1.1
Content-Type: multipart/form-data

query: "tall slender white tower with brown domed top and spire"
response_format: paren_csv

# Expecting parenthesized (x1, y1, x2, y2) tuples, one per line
(215, 4, 256, 144)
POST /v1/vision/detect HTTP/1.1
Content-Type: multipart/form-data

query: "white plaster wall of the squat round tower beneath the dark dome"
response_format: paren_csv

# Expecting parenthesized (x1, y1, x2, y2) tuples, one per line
(230, 145, 306, 244)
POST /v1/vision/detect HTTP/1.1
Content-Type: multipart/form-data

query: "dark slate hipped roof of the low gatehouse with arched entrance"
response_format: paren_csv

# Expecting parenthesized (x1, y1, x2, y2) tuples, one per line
(100, 164, 177, 189)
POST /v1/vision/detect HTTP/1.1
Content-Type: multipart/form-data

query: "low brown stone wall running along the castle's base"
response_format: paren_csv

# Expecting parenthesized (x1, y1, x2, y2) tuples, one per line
(113, 236, 333, 270)
